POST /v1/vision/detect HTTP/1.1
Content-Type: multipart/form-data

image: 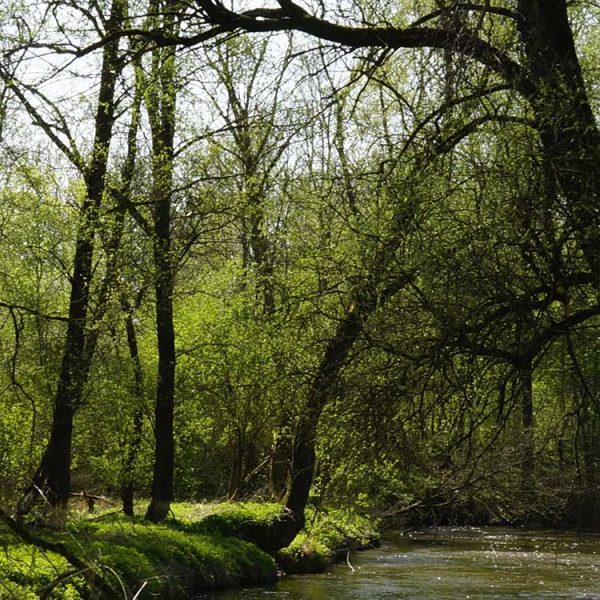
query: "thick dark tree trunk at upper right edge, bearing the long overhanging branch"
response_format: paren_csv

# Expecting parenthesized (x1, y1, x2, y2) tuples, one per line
(518, 0, 600, 284)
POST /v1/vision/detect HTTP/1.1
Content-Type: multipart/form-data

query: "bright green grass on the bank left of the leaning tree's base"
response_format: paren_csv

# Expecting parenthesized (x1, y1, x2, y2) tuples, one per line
(0, 505, 277, 600)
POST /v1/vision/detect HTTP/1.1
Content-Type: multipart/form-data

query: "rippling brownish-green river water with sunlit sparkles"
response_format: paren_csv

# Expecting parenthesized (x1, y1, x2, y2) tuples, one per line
(202, 528, 600, 600)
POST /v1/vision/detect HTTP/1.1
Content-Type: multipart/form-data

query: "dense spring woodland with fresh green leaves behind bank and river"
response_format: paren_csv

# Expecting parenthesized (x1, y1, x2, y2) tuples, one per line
(0, 0, 600, 549)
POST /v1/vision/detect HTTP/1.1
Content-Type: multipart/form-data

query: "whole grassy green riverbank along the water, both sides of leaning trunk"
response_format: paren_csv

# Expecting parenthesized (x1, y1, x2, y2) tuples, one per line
(0, 503, 377, 600)
